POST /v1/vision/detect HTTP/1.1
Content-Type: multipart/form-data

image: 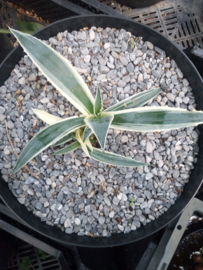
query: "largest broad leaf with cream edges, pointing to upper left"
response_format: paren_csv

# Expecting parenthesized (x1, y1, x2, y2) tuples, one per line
(9, 28, 94, 115)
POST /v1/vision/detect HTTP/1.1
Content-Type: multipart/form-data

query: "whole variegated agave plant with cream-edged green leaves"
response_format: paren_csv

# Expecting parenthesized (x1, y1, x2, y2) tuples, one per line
(10, 29, 203, 173)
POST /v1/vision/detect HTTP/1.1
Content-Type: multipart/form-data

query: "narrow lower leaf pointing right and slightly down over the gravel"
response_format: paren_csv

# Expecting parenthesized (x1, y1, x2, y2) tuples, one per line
(88, 147, 148, 167)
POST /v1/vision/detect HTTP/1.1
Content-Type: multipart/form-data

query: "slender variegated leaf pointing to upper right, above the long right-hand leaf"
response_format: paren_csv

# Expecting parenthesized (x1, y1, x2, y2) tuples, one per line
(105, 88, 161, 112)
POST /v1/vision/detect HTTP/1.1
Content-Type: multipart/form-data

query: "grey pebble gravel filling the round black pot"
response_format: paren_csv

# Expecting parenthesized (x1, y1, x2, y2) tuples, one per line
(0, 27, 199, 236)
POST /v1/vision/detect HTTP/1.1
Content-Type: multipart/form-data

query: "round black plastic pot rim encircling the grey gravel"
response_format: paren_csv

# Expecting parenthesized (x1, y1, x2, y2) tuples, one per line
(0, 15, 203, 247)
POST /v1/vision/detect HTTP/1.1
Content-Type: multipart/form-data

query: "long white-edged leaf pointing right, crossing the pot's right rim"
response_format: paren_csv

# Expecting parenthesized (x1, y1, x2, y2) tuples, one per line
(111, 107, 203, 132)
